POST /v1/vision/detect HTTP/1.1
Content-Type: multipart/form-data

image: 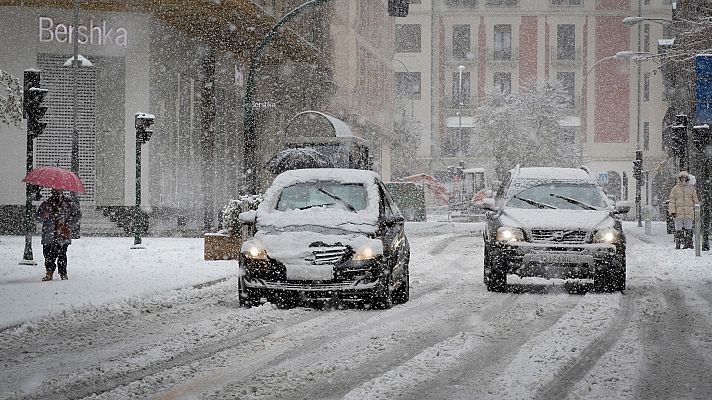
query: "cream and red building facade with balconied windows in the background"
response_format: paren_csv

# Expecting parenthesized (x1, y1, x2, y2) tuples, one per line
(394, 0, 671, 206)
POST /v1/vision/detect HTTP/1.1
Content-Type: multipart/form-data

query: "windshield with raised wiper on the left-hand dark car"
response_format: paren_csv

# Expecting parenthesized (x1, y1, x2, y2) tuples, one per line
(276, 182, 367, 211)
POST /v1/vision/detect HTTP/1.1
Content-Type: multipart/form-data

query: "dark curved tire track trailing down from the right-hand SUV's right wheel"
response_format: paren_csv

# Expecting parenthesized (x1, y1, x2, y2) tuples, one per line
(534, 295, 634, 400)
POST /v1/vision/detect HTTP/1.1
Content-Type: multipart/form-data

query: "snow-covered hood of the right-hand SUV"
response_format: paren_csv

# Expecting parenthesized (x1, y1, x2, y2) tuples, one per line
(500, 208, 615, 230)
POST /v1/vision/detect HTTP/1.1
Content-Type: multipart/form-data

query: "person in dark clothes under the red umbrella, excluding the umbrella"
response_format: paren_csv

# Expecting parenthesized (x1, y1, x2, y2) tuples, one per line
(37, 190, 81, 281)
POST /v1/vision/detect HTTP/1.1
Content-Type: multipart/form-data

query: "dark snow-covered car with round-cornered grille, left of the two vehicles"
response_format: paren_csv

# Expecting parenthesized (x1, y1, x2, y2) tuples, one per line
(239, 168, 410, 308)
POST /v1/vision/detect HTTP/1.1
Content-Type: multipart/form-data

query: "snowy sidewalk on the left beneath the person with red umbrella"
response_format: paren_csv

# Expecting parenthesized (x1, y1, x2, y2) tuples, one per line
(0, 236, 237, 330)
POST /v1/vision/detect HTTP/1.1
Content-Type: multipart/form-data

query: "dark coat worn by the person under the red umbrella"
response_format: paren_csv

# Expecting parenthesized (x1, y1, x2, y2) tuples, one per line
(37, 195, 82, 245)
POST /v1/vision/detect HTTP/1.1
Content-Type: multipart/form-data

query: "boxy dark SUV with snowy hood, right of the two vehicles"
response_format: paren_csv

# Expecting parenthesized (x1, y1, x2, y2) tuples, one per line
(484, 167, 630, 292)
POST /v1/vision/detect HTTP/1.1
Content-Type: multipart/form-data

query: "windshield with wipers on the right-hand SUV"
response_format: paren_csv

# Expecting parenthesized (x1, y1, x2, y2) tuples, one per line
(506, 183, 607, 210)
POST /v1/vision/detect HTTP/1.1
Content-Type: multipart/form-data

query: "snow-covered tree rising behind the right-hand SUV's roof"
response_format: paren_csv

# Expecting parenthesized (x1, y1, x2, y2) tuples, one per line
(476, 81, 582, 180)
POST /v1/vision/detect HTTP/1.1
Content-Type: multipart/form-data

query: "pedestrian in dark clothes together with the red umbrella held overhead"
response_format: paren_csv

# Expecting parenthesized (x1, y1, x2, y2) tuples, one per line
(22, 167, 84, 281)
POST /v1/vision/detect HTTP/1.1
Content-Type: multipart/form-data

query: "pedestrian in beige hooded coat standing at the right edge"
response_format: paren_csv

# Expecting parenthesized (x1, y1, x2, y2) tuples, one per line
(668, 171, 699, 249)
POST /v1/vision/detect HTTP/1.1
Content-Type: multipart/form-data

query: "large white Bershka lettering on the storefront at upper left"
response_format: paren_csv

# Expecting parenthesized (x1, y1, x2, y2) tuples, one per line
(37, 17, 128, 47)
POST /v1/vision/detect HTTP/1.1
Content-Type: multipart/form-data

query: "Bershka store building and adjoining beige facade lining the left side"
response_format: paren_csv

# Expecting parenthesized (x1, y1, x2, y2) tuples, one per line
(0, 0, 394, 233)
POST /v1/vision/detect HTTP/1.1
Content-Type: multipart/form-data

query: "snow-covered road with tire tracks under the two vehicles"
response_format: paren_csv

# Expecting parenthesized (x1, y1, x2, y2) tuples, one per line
(0, 228, 712, 399)
